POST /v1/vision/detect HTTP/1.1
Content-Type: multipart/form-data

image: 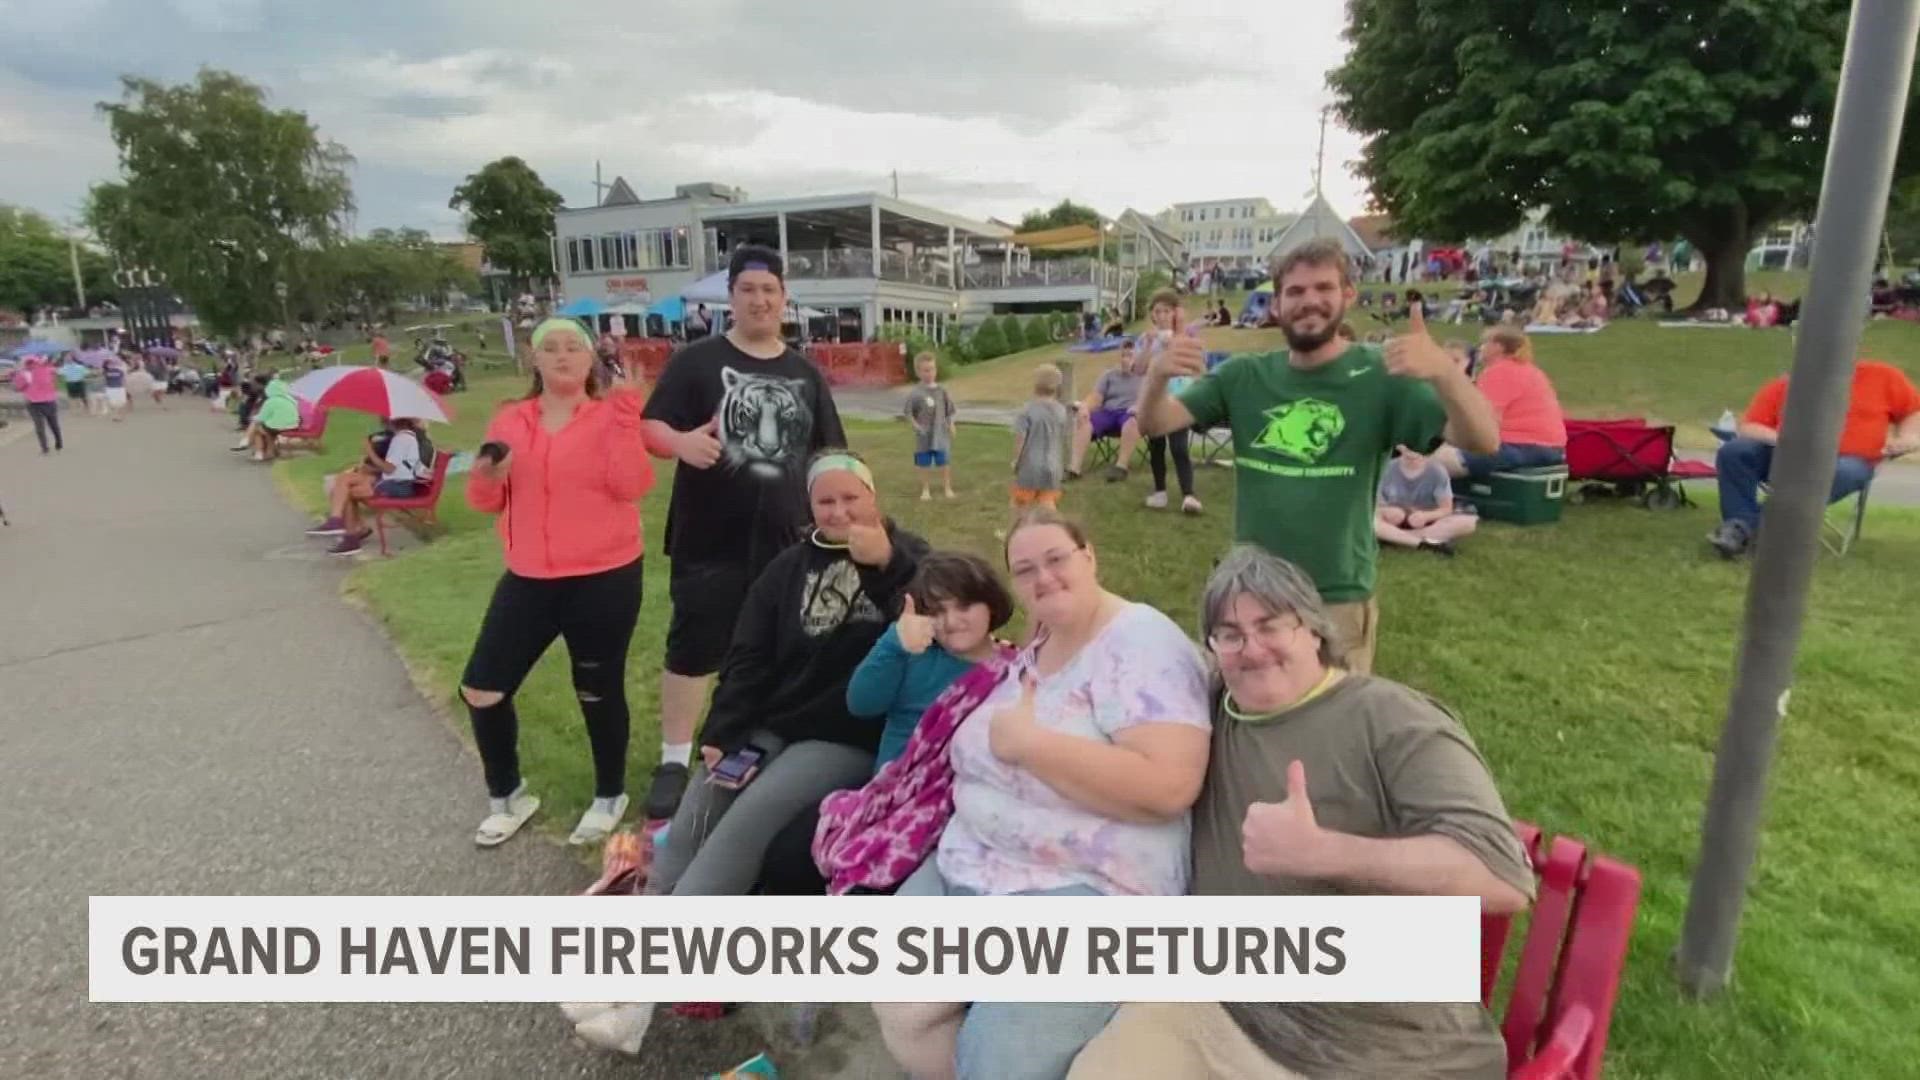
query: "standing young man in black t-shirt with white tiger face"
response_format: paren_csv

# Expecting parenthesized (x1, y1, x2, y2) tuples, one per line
(643, 244, 847, 819)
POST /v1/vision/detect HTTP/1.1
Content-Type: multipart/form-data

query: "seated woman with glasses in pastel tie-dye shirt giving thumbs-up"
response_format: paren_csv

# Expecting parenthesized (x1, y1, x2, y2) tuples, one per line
(876, 507, 1212, 1080)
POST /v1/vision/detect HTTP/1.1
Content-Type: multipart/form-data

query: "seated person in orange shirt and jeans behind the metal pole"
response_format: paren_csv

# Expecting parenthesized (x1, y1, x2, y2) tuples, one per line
(1707, 359, 1920, 559)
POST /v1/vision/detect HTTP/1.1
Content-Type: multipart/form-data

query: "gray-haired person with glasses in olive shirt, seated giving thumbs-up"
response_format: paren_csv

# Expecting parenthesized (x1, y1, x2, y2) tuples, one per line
(1069, 546, 1534, 1080)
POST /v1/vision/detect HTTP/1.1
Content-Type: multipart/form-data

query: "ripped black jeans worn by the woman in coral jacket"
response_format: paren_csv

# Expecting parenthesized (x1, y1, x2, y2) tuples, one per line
(461, 559, 641, 798)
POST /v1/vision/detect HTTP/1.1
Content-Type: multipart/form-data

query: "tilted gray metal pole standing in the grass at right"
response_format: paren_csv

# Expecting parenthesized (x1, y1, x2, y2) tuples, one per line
(1676, 0, 1920, 997)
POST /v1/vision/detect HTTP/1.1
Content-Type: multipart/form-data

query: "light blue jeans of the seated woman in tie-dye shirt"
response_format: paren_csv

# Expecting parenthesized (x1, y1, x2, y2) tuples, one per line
(895, 855, 1119, 1080)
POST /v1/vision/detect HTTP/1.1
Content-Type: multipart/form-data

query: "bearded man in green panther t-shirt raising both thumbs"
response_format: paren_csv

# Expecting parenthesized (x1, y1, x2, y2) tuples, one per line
(1137, 240, 1500, 671)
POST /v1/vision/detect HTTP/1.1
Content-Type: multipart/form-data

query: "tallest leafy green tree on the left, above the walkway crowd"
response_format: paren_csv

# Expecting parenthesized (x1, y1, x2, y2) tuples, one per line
(86, 67, 353, 332)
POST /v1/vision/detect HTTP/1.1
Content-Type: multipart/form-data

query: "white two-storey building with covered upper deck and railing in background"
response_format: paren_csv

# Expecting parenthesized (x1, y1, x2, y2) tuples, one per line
(553, 181, 1133, 340)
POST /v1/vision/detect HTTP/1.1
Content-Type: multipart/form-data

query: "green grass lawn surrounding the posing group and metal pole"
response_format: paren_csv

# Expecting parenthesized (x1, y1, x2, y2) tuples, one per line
(276, 323, 1920, 1078)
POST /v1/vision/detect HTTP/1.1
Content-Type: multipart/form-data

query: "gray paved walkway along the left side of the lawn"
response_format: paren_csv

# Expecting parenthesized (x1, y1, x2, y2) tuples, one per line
(0, 404, 890, 1078)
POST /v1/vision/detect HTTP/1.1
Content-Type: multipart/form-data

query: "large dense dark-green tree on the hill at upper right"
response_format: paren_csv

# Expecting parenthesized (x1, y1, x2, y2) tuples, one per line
(1329, 0, 1920, 307)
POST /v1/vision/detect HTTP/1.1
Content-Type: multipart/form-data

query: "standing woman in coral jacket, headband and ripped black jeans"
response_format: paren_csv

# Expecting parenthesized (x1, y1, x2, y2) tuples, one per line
(461, 319, 653, 847)
